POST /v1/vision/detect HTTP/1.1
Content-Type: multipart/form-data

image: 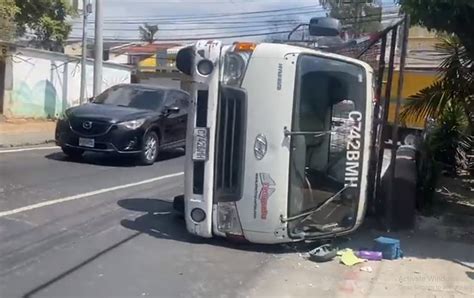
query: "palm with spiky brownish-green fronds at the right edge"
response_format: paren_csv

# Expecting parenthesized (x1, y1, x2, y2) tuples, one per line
(401, 36, 474, 171)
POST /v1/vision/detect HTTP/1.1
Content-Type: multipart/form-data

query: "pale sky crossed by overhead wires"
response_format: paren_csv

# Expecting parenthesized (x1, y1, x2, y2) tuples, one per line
(70, 0, 393, 41)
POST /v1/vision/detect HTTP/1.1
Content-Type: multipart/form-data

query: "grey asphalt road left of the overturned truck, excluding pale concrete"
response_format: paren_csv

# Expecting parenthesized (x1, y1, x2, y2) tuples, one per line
(0, 148, 288, 297)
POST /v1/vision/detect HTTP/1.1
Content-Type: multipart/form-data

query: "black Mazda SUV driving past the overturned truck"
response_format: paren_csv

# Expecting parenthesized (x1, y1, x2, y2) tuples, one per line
(55, 84, 190, 165)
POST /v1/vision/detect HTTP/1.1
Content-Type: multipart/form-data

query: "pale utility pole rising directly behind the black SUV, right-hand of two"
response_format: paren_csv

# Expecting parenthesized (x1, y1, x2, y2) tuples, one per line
(94, 0, 104, 96)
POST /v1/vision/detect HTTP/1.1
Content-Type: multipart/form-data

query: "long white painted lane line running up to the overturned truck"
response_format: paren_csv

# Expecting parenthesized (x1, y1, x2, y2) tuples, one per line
(0, 172, 184, 217)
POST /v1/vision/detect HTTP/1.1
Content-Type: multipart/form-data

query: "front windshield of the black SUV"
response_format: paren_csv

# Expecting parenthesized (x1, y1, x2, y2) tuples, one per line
(93, 86, 165, 111)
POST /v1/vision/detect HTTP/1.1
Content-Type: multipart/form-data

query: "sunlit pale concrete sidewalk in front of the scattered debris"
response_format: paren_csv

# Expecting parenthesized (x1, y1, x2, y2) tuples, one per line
(243, 217, 474, 297)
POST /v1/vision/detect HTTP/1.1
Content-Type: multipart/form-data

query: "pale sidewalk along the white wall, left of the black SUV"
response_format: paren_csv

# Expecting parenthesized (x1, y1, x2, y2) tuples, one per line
(0, 119, 56, 147)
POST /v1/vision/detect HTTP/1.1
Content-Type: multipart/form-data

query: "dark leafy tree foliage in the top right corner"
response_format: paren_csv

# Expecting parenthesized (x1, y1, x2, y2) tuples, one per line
(397, 0, 474, 59)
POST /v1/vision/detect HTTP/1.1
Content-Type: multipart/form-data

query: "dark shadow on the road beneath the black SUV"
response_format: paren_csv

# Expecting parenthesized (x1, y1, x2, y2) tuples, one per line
(45, 149, 184, 167)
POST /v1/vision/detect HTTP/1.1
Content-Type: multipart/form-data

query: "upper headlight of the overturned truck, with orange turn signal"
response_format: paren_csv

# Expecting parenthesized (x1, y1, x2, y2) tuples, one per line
(222, 43, 256, 87)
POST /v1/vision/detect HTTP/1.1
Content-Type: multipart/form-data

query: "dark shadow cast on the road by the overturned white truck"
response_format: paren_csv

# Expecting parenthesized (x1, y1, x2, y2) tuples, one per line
(117, 198, 314, 254)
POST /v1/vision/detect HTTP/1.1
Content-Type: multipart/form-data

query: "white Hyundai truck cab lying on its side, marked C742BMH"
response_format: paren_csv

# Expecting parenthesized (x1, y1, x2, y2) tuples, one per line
(176, 18, 374, 243)
